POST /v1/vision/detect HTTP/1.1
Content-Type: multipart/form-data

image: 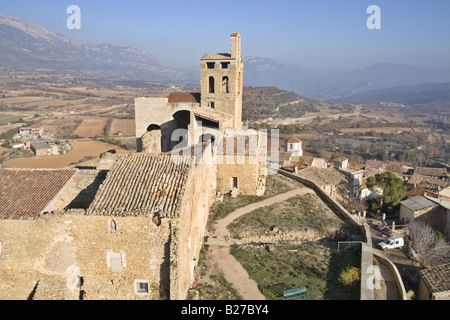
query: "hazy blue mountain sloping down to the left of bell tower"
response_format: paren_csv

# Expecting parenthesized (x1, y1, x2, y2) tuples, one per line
(0, 14, 198, 82)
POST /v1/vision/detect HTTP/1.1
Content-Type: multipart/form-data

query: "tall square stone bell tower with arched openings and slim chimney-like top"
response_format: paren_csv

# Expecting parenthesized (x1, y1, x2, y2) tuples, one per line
(200, 32, 244, 128)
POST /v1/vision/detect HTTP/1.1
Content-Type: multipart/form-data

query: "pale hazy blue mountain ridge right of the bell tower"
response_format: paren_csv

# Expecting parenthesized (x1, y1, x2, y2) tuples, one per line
(244, 56, 450, 100)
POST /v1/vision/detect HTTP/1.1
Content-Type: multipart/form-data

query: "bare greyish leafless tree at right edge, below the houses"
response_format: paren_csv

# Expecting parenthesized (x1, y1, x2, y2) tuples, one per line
(409, 221, 450, 267)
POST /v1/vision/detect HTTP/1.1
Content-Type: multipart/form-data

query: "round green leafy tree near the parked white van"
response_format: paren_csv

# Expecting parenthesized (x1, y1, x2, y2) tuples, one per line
(367, 171, 406, 211)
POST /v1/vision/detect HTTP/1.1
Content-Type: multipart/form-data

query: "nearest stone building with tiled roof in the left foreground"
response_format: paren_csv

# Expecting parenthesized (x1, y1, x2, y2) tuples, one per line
(0, 146, 215, 300)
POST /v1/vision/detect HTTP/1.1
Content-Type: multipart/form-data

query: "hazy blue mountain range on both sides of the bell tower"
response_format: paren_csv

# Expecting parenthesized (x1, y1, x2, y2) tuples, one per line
(0, 14, 450, 100)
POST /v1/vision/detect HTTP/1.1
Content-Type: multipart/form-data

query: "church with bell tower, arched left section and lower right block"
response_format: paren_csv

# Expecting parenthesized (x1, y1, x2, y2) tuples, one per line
(135, 32, 268, 195)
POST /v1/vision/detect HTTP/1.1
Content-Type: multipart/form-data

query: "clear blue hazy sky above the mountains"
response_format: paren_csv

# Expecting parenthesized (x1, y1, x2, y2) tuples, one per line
(0, 0, 450, 71)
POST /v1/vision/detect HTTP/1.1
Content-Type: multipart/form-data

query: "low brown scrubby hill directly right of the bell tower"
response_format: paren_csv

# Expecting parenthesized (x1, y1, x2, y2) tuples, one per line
(242, 87, 318, 121)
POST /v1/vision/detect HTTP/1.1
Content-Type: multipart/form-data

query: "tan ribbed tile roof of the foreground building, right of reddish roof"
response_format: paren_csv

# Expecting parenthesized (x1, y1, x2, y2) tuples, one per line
(86, 153, 191, 217)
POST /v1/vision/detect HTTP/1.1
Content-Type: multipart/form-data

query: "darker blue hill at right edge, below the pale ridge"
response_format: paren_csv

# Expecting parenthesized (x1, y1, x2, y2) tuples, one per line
(337, 82, 450, 113)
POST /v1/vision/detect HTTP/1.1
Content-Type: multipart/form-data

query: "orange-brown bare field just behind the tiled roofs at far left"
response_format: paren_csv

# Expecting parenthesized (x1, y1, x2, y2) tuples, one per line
(3, 141, 131, 169)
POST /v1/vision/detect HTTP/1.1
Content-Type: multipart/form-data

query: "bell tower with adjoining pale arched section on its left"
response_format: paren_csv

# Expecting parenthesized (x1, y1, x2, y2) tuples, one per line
(135, 33, 243, 153)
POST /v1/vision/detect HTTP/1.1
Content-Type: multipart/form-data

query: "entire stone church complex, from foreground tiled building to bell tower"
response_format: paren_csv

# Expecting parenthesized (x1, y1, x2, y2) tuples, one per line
(0, 33, 267, 300)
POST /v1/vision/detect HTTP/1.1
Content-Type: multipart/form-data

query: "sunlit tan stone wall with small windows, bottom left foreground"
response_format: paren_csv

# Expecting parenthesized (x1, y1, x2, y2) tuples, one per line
(0, 210, 170, 300)
